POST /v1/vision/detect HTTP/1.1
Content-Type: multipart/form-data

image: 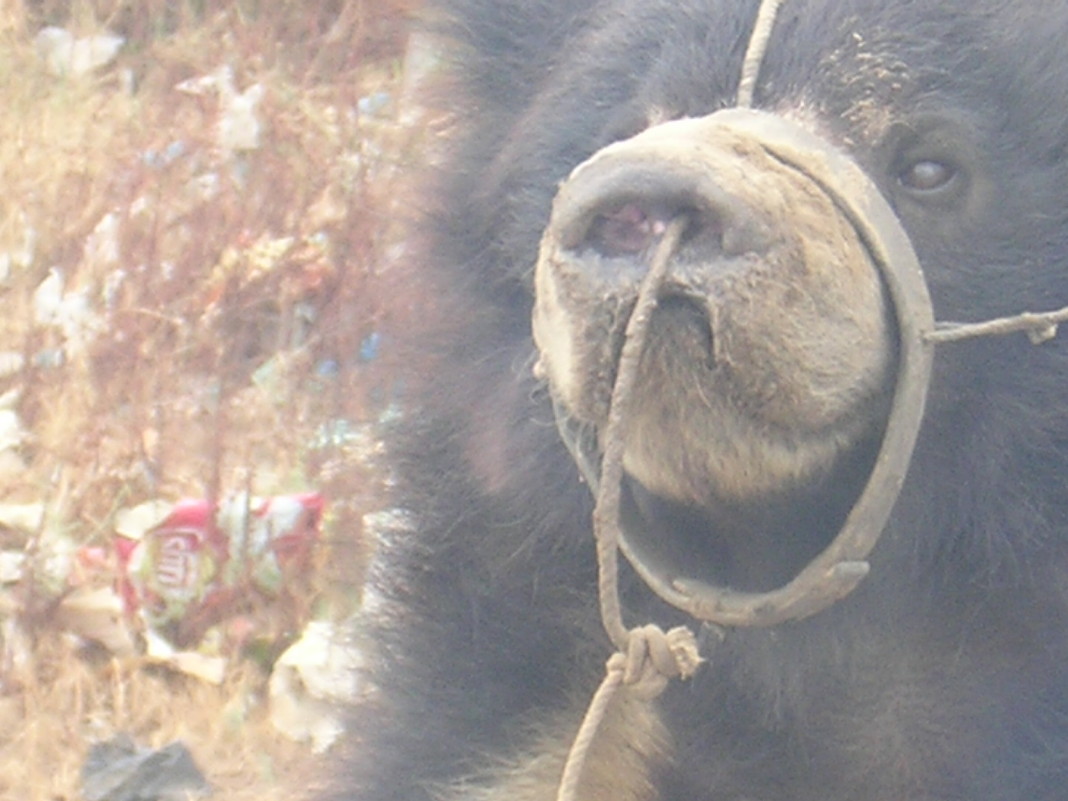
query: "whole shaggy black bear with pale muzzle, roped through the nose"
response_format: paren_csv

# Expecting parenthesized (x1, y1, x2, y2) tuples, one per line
(342, 0, 1068, 801)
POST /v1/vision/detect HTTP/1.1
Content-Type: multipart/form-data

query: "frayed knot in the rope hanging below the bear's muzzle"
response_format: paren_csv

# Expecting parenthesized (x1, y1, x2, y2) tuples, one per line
(608, 624, 702, 701)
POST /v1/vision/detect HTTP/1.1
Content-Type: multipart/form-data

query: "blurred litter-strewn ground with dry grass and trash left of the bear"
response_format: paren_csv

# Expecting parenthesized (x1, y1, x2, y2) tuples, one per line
(0, 0, 427, 801)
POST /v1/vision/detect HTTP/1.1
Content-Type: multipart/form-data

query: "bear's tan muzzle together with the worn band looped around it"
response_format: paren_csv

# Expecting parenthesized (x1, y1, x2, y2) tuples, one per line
(533, 109, 931, 619)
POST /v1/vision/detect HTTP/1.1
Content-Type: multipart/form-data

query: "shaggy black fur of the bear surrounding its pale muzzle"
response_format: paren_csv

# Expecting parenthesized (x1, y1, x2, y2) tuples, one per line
(342, 0, 1068, 801)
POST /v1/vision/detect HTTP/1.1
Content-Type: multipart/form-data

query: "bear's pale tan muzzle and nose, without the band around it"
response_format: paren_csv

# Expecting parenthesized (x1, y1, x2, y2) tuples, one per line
(533, 120, 896, 503)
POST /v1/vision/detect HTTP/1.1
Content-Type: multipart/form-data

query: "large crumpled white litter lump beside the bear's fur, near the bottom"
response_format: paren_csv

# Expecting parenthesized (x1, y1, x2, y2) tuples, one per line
(268, 621, 361, 753)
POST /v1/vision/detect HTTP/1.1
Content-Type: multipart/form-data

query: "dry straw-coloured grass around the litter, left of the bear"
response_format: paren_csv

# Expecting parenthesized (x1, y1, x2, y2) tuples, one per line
(0, 0, 415, 801)
